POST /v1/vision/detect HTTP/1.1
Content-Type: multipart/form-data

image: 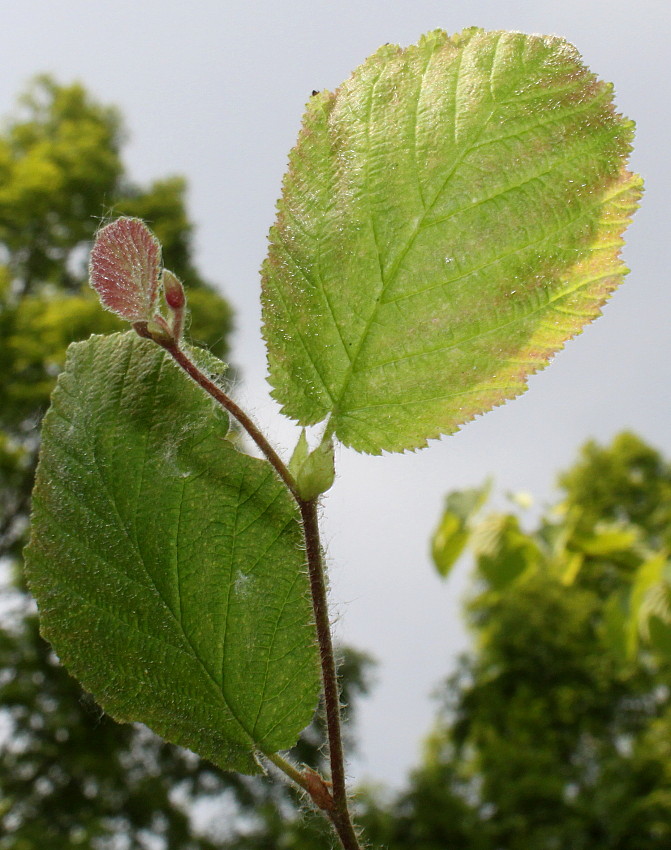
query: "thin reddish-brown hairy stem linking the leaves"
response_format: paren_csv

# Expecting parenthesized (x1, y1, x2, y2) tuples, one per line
(159, 338, 361, 850)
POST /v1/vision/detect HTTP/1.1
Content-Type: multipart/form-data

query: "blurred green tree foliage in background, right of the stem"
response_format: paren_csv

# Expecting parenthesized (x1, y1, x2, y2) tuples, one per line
(368, 434, 671, 850)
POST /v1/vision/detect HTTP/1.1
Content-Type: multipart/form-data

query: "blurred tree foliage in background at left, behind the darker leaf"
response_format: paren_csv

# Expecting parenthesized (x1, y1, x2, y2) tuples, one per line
(0, 77, 239, 850)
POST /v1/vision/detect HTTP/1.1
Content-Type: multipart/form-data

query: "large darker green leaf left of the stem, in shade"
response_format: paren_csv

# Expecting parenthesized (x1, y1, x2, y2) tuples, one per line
(27, 333, 319, 773)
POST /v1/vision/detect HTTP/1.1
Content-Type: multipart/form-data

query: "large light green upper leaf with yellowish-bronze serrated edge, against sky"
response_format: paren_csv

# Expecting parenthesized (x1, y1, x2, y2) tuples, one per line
(262, 29, 641, 454)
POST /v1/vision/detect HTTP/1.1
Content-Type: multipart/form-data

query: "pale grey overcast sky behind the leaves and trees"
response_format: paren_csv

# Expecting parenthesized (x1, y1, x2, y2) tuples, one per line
(0, 0, 671, 784)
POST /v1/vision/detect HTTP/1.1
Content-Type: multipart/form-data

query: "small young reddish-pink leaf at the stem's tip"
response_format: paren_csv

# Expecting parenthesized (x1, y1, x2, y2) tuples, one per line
(90, 218, 161, 322)
